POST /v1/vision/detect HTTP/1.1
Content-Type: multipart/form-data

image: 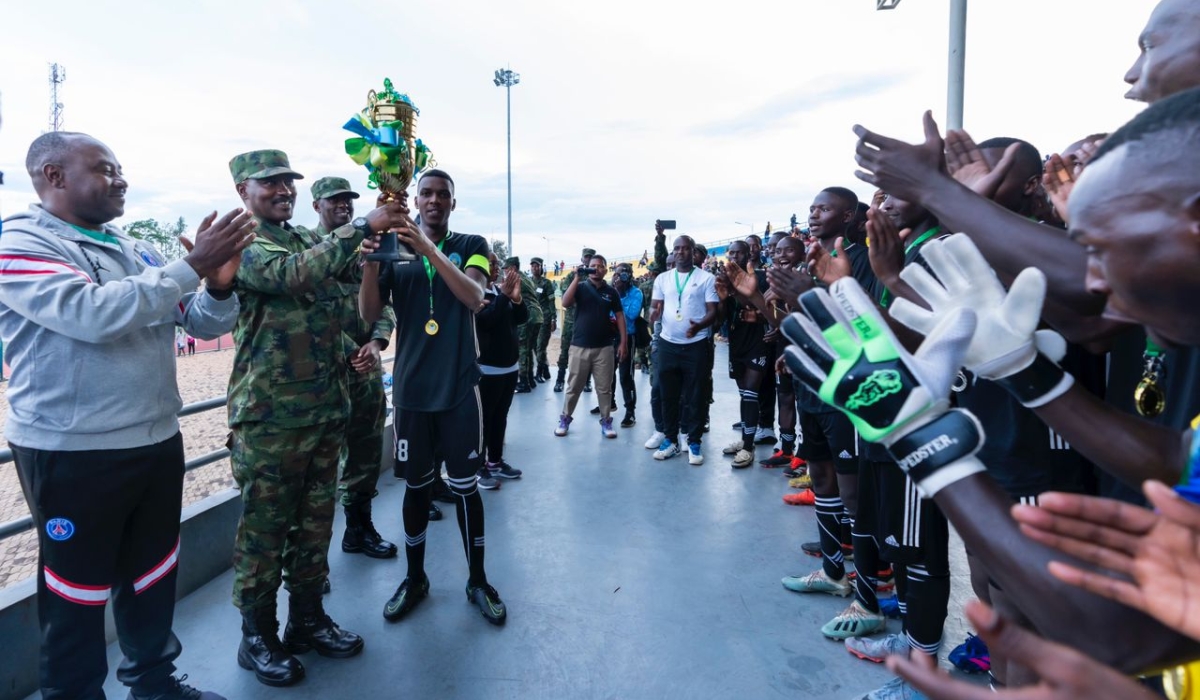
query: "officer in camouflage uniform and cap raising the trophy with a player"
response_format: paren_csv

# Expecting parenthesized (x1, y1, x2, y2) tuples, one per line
(229, 150, 404, 686)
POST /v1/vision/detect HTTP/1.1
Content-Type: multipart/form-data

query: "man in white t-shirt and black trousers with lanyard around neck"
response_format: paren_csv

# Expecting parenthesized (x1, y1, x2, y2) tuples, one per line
(650, 235, 719, 465)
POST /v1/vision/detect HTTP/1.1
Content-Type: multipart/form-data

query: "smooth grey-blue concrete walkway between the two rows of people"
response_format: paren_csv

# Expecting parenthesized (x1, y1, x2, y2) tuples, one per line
(56, 345, 970, 700)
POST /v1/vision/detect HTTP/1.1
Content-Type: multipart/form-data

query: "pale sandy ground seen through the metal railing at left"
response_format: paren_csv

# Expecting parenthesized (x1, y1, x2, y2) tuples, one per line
(0, 337, 558, 588)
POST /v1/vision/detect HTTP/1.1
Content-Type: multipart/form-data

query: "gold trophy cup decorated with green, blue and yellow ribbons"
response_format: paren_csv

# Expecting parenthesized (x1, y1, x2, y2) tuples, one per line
(343, 78, 433, 262)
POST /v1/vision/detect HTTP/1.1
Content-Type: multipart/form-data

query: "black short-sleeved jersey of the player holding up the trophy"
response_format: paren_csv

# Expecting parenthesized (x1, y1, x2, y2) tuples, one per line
(379, 232, 488, 412)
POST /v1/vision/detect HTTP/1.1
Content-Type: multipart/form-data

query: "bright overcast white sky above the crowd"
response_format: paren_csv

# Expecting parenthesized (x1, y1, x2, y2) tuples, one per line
(0, 0, 1154, 261)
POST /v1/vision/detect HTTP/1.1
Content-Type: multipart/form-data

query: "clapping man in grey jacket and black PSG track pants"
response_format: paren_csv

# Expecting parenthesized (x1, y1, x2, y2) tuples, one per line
(0, 132, 254, 700)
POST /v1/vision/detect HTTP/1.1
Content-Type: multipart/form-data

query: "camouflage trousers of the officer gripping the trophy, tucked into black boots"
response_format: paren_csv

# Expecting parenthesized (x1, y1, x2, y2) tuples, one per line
(229, 420, 346, 610)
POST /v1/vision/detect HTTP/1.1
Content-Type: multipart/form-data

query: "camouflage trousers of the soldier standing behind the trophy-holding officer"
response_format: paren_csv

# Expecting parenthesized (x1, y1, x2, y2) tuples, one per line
(337, 371, 388, 505)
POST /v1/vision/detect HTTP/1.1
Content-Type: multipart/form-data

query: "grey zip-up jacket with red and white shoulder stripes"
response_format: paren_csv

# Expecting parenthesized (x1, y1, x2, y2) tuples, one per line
(0, 205, 239, 451)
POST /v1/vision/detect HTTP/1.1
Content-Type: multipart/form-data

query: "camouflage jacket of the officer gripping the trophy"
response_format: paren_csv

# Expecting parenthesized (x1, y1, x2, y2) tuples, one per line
(229, 221, 362, 427)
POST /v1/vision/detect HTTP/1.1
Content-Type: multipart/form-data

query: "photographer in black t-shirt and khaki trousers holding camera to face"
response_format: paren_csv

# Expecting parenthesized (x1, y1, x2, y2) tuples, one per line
(554, 255, 629, 437)
